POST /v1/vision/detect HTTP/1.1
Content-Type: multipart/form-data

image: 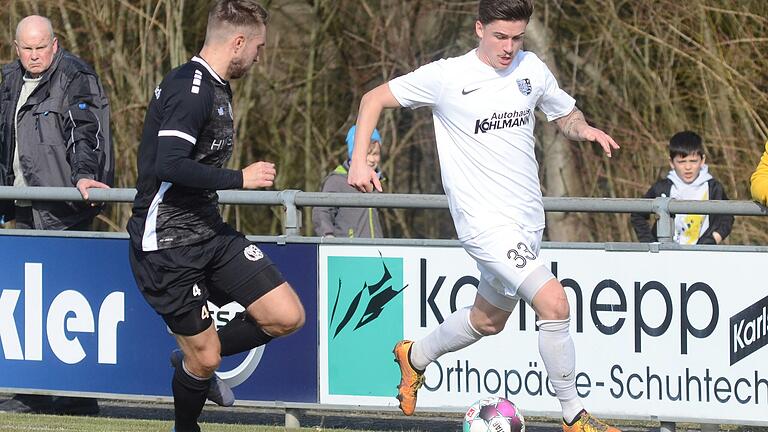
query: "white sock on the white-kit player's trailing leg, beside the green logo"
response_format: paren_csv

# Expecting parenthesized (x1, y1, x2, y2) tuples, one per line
(411, 307, 483, 371)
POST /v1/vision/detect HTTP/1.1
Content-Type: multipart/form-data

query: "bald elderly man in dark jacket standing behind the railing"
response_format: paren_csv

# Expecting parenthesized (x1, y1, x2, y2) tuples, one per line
(0, 15, 114, 414)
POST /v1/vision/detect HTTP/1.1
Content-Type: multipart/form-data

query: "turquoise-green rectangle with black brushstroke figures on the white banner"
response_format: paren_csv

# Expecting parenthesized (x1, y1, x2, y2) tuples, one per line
(328, 256, 405, 396)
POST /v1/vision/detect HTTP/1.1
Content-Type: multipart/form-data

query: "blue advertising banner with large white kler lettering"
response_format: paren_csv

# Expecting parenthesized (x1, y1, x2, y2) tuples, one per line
(0, 236, 318, 402)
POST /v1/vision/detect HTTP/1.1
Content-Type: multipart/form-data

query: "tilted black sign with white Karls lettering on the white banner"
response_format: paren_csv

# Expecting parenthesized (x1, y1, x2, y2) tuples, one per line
(730, 297, 768, 365)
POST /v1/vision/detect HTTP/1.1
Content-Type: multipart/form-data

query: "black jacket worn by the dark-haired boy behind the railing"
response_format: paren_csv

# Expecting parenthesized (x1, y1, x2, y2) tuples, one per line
(629, 178, 733, 244)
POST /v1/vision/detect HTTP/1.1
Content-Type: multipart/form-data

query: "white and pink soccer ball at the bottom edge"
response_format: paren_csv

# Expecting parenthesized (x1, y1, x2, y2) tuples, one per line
(464, 396, 525, 432)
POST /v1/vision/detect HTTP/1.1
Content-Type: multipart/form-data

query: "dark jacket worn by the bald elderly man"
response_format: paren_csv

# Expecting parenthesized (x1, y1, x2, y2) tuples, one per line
(0, 48, 114, 230)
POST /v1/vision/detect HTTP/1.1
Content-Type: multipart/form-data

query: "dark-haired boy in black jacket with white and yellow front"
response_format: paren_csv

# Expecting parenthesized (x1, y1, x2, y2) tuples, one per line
(630, 131, 733, 244)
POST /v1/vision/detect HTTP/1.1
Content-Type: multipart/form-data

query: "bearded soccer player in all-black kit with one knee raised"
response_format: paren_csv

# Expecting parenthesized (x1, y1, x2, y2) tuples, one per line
(128, 0, 305, 432)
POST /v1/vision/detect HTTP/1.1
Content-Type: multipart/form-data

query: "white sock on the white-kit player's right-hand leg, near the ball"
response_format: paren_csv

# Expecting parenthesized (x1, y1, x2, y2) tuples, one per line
(536, 318, 584, 422)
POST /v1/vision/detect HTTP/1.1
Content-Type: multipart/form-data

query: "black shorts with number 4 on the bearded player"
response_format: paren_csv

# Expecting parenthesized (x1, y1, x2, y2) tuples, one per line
(129, 224, 285, 334)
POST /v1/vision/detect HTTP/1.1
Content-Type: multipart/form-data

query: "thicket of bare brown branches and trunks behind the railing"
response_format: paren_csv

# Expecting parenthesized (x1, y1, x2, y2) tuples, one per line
(0, 0, 768, 244)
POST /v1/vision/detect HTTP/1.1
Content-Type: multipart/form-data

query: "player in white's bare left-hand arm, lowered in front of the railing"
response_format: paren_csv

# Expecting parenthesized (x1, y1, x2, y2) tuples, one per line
(347, 83, 400, 192)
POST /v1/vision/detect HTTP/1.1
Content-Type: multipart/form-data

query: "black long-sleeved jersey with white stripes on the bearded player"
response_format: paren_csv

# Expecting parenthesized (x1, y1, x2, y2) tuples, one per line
(128, 57, 243, 251)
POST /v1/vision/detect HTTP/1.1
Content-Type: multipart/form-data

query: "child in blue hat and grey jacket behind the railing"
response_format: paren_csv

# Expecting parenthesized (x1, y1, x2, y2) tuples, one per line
(312, 126, 382, 238)
